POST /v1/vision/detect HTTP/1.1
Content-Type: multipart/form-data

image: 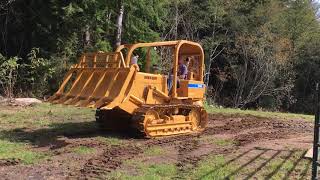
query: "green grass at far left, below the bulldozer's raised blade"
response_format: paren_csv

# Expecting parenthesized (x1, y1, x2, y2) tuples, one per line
(0, 103, 96, 164)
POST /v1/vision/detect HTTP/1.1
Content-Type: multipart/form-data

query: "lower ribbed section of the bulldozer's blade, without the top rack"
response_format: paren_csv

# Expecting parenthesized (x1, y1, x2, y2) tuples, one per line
(49, 68, 134, 108)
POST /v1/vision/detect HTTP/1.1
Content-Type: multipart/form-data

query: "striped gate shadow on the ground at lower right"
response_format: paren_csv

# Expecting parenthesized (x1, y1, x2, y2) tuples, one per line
(199, 148, 311, 179)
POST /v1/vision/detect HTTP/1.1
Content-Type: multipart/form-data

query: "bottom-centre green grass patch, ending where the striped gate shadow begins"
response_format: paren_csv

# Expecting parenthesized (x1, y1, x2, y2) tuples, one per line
(109, 155, 238, 180)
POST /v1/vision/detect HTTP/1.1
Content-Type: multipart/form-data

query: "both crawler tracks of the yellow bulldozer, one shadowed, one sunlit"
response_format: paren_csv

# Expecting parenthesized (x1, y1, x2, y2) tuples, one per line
(96, 104, 207, 137)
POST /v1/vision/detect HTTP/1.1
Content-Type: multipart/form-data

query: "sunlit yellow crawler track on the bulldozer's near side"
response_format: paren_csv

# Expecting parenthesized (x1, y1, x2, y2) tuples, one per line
(132, 104, 207, 137)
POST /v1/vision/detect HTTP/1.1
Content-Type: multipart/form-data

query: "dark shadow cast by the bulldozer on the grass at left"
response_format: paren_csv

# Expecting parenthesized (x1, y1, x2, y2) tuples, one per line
(0, 121, 136, 149)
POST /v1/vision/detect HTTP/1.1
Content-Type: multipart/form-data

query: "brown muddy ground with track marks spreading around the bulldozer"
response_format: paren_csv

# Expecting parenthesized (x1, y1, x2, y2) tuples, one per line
(0, 107, 313, 179)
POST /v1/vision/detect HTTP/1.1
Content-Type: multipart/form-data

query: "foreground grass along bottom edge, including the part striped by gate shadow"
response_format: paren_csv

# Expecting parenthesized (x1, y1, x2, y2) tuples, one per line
(107, 151, 311, 180)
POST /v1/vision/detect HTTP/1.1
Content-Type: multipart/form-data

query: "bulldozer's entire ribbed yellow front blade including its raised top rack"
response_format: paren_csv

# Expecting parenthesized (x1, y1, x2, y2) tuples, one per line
(48, 52, 135, 108)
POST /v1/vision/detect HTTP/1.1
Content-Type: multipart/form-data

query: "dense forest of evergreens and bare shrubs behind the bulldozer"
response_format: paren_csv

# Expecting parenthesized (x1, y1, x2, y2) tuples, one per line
(0, 0, 320, 113)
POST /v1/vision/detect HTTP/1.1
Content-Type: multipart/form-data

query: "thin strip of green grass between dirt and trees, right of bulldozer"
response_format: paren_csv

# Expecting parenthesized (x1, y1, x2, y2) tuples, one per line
(205, 105, 314, 121)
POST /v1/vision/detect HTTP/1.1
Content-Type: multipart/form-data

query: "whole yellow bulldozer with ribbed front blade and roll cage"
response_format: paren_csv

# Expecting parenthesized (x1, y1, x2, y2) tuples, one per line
(48, 40, 207, 137)
